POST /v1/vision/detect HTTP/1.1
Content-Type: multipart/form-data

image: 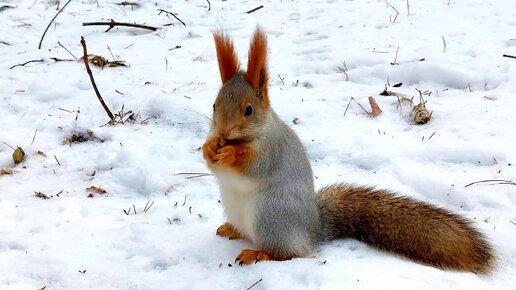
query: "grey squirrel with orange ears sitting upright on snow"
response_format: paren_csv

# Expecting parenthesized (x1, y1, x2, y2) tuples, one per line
(202, 27, 495, 273)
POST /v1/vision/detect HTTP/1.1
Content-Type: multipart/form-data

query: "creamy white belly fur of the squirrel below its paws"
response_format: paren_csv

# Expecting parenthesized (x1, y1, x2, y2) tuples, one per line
(214, 169, 260, 242)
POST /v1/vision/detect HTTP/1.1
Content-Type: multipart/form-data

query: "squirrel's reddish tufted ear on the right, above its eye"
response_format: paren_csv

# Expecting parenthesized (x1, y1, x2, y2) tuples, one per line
(246, 27, 269, 105)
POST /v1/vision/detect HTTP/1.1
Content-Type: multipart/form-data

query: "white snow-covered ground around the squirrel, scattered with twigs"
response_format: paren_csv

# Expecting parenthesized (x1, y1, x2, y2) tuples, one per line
(0, 0, 516, 289)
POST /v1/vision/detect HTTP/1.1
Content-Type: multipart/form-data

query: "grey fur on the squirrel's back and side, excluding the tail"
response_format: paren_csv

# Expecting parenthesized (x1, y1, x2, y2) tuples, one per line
(251, 109, 319, 258)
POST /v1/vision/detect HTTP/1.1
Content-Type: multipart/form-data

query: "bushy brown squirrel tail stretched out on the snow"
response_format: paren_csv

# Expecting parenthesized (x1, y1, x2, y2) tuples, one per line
(317, 184, 495, 273)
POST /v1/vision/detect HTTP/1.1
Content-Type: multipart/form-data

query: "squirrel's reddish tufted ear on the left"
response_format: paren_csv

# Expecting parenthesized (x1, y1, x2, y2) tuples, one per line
(213, 30, 239, 83)
